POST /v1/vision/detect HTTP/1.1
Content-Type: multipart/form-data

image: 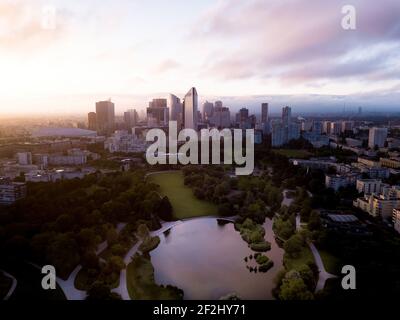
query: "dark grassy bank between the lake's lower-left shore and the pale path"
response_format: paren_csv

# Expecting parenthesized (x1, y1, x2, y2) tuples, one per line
(126, 255, 183, 300)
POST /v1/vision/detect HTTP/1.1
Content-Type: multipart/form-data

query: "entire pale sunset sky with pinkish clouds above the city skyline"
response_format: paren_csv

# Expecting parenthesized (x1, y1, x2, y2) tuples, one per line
(0, 0, 400, 116)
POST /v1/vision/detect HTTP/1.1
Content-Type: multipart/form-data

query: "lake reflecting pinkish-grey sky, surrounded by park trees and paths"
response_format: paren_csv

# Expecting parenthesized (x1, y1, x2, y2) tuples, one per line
(150, 218, 284, 300)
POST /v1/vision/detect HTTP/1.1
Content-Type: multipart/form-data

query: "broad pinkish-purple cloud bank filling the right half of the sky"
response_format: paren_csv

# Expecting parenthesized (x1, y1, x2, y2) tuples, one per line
(191, 0, 400, 81)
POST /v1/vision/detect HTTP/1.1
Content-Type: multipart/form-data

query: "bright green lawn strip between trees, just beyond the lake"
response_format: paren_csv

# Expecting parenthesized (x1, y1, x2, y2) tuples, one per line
(148, 171, 218, 219)
